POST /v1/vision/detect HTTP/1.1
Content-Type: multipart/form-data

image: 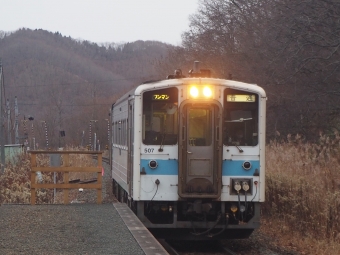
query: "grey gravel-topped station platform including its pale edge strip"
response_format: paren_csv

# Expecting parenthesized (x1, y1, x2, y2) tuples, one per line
(0, 203, 168, 255)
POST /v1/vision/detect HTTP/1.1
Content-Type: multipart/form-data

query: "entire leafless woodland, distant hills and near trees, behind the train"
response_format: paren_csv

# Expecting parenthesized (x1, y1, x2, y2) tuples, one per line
(0, 0, 340, 146)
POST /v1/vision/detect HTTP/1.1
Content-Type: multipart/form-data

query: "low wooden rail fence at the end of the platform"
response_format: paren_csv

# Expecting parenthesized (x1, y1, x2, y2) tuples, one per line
(29, 151, 103, 205)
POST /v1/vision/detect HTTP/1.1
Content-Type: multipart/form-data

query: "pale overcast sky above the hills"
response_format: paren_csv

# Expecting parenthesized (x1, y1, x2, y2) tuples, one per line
(0, 0, 199, 45)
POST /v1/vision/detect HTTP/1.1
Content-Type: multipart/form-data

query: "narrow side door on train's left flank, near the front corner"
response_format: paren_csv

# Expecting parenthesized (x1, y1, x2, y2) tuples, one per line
(127, 100, 134, 197)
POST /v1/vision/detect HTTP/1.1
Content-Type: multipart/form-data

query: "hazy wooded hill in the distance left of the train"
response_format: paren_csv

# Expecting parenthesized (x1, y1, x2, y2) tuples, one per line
(0, 29, 171, 148)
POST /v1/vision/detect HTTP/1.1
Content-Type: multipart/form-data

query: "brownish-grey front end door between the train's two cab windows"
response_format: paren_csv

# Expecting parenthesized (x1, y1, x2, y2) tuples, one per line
(179, 103, 222, 198)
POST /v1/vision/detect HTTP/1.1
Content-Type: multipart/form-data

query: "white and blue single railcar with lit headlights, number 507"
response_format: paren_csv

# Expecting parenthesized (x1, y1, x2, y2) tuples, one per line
(111, 62, 267, 239)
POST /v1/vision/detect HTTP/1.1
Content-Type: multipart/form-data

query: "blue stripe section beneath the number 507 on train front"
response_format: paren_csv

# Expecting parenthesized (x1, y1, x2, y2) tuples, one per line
(140, 159, 178, 175)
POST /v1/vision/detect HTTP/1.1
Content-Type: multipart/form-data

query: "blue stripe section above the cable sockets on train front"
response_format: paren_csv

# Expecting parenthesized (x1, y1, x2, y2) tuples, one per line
(222, 160, 260, 176)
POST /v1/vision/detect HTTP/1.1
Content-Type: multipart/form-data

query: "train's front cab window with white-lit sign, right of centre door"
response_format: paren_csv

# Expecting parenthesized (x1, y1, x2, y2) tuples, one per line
(223, 89, 259, 146)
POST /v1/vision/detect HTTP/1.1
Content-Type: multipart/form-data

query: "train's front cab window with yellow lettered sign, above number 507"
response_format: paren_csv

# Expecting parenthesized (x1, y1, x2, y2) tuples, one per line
(143, 88, 178, 145)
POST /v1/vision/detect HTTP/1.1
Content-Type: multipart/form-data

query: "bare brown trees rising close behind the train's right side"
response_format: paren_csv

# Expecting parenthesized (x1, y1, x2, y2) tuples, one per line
(159, 0, 340, 140)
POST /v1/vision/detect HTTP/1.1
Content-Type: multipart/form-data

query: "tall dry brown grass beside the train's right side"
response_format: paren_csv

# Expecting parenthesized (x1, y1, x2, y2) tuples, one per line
(261, 133, 340, 254)
